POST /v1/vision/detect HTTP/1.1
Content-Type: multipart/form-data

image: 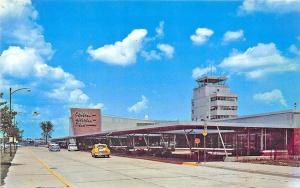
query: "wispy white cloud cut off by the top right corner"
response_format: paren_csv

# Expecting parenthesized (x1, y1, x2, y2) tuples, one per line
(240, 0, 300, 13)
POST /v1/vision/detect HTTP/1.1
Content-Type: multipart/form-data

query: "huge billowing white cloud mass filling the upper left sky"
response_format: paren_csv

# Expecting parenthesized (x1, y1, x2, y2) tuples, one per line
(0, 0, 93, 106)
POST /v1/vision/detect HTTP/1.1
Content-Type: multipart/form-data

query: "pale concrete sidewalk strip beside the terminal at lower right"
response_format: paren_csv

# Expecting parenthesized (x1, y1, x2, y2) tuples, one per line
(202, 162, 300, 179)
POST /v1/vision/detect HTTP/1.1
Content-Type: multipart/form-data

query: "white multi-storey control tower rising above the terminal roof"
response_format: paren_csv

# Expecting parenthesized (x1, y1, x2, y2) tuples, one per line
(192, 76, 238, 121)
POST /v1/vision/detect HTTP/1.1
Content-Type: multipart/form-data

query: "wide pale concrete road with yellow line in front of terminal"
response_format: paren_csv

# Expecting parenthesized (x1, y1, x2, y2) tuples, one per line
(4, 147, 300, 188)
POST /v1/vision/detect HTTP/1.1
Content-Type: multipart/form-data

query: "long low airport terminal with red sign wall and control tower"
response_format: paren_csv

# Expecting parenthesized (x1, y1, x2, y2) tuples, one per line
(52, 77, 300, 159)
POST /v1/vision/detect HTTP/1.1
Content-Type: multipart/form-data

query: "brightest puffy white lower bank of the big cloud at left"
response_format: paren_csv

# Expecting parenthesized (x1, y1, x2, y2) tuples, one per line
(0, 46, 89, 103)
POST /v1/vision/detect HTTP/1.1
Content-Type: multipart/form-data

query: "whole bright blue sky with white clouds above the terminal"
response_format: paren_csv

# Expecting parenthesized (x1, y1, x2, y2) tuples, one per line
(0, 0, 300, 138)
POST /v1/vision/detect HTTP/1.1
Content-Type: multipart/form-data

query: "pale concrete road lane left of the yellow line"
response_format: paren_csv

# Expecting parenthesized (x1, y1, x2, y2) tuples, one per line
(3, 148, 64, 188)
